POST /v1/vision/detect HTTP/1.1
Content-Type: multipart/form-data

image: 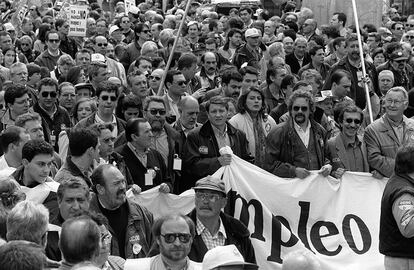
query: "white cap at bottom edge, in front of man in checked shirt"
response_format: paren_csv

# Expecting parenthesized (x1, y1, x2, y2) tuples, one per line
(202, 245, 258, 270)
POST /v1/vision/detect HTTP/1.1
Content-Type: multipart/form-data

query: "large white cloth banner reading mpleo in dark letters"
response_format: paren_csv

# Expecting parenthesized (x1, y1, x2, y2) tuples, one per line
(133, 156, 386, 270)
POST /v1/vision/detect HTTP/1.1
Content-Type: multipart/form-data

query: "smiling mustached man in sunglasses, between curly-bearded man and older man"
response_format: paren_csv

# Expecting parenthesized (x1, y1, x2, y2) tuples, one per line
(327, 105, 369, 179)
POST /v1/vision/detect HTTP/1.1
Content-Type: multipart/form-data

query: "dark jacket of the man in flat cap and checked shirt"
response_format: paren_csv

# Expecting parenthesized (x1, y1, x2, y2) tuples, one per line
(188, 210, 256, 263)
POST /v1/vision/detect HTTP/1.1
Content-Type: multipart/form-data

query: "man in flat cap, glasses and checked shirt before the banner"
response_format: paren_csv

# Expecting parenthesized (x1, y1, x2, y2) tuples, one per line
(188, 175, 256, 263)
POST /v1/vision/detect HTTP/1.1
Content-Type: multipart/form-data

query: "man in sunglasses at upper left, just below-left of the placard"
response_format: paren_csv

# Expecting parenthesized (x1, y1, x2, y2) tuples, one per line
(34, 30, 64, 71)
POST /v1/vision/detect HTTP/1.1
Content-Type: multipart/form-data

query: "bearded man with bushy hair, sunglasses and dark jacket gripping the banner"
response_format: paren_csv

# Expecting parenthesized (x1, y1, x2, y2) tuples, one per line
(265, 90, 332, 179)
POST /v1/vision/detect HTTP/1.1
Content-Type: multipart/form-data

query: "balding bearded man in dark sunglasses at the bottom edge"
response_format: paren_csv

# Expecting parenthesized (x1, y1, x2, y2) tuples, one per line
(124, 215, 201, 270)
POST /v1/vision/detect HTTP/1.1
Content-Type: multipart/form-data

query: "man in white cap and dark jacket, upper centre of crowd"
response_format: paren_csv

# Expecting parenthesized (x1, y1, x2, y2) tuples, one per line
(232, 28, 263, 69)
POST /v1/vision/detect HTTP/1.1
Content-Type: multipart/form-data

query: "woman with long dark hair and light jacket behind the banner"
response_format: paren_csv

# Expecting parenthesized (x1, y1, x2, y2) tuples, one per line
(229, 87, 276, 167)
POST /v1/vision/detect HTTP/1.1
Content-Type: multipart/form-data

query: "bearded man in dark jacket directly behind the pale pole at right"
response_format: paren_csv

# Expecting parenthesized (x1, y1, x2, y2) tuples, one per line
(322, 34, 381, 109)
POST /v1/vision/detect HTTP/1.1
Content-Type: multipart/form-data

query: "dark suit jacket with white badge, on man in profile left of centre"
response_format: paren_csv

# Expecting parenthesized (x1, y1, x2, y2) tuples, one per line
(115, 144, 172, 191)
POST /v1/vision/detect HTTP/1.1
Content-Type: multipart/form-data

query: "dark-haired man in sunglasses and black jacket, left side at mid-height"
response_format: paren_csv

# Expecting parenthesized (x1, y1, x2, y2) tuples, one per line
(33, 78, 71, 152)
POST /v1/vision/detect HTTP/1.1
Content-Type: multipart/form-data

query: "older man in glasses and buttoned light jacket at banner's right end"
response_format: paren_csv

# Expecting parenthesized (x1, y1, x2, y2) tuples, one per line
(364, 86, 414, 177)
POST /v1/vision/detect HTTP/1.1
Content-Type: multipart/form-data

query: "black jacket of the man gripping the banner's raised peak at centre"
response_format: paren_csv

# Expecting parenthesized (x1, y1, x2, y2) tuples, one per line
(183, 121, 252, 189)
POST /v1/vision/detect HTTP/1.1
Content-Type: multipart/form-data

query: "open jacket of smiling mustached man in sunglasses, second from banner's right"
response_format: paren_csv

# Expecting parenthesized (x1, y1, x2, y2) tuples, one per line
(326, 134, 369, 172)
